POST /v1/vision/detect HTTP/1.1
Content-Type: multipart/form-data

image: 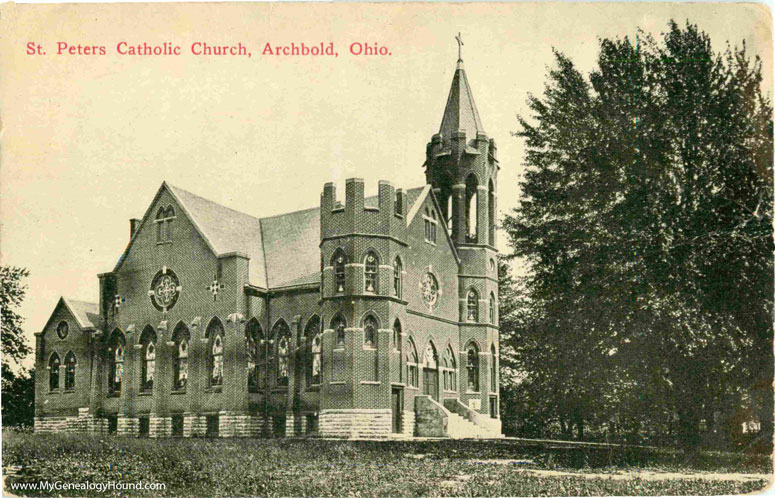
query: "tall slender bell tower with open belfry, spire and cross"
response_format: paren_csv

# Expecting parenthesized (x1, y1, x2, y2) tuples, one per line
(424, 34, 500, 422)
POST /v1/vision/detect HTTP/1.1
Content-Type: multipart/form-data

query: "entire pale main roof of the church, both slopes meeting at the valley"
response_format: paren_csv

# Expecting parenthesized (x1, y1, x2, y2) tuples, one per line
(166, 184, 424, 290)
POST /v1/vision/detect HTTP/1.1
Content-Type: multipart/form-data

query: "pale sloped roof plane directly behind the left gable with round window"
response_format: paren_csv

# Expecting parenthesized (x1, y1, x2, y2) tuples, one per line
(167, 184, 267, 287)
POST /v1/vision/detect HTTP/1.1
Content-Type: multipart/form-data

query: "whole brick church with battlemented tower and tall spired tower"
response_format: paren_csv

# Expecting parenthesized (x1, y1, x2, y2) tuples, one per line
(35, 49, 501, 438)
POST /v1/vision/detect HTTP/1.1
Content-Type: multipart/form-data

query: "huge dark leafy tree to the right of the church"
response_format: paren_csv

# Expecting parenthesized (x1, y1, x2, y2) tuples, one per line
(504, 22, 773, 446)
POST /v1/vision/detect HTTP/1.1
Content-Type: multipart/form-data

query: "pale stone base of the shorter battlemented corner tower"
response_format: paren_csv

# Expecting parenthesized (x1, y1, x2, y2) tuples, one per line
(318, 410, 392, 438)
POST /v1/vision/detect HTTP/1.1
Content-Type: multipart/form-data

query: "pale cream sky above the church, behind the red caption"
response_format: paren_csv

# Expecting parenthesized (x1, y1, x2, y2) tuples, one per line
(0, 3, 773, 368)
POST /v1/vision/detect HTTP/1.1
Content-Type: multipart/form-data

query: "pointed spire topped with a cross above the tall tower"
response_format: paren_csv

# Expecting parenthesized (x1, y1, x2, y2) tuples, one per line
(439, 33, 484, 139)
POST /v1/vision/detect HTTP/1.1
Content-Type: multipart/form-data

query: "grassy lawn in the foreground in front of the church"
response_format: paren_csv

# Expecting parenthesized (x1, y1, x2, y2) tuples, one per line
(3, 430, 772, 497)
